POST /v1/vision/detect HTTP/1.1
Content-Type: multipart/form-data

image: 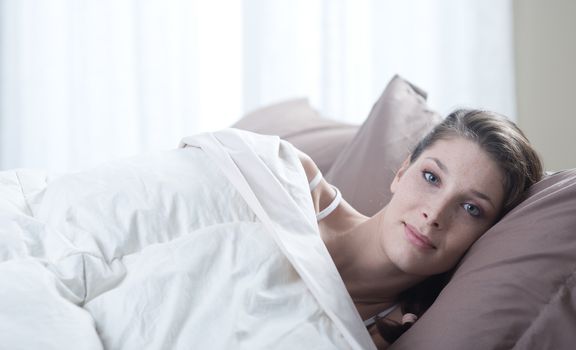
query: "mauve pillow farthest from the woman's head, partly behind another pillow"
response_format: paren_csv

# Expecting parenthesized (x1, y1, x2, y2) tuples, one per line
(233, 99, 358, 173)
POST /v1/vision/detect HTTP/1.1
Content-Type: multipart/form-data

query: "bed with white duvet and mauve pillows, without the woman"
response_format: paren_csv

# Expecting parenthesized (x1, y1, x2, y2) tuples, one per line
(0, 76, 576, 349)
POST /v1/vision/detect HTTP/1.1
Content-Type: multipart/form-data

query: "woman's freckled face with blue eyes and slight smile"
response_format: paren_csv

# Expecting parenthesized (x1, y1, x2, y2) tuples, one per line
(381, 138, 504, 276)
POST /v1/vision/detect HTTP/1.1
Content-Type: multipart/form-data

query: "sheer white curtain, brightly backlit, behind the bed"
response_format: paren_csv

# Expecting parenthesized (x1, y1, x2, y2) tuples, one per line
(0, 0, 515, 171)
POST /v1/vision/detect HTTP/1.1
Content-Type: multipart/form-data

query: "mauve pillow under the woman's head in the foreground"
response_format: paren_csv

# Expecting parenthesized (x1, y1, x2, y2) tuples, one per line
(391, 169, 576, 350)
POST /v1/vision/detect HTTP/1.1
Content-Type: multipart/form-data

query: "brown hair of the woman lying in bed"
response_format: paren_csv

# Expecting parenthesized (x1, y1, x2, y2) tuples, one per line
(376, 109, 543, 343)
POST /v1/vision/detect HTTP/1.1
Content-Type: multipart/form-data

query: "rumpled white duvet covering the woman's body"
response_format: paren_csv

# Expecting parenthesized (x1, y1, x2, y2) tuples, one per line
(0, 129, 374, 349)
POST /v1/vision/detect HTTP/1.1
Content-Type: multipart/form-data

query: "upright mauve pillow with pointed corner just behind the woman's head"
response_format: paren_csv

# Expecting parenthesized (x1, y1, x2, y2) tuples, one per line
(326, 76, 442, 216)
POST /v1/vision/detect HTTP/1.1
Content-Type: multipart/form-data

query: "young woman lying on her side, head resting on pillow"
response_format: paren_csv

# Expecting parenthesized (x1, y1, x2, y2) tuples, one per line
(301, 110, 542, 348)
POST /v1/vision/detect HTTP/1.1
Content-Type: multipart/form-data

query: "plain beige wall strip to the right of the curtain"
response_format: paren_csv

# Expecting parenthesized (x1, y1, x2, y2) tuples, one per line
(513, 0, 576, 170)
